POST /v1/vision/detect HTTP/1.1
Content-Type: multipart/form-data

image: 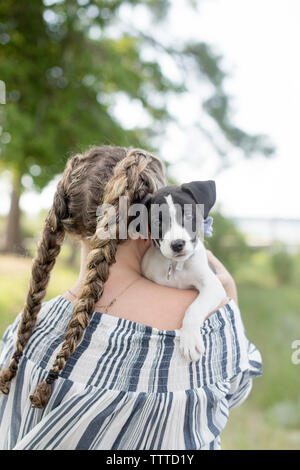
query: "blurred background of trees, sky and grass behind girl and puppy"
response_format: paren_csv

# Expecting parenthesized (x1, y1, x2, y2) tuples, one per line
(0, 0, 300, 449)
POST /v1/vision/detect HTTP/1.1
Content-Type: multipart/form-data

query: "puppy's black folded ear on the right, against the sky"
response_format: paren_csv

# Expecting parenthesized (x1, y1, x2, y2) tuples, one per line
(180, 180, 216, 219)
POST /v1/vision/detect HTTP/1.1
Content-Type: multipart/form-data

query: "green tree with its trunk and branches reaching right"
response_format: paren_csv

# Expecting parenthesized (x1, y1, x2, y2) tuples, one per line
(0, 0, 272, 251)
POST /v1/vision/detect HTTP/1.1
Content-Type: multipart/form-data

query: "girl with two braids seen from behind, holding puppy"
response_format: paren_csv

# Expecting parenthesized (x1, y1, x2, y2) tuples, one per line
(0, 146, 261, 450)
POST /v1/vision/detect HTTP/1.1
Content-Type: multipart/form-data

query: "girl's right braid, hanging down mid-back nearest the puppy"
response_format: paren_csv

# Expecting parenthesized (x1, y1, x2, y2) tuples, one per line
(30, 149, 163, 408)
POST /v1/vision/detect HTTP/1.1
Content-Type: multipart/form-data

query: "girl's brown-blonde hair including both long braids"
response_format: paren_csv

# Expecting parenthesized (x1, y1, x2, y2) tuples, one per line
(0, 146, 166, 408)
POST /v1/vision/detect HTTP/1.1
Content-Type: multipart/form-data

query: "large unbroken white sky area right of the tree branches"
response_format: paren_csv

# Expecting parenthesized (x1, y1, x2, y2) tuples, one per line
(163, 0, 300, 218)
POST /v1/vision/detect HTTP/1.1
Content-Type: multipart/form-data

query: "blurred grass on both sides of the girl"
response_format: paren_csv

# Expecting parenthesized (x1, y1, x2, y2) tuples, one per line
(0, 248, 300, 449)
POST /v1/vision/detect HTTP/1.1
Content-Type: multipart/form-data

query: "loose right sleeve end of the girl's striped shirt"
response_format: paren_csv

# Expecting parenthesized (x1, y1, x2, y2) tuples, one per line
(226, 340, 262, 408)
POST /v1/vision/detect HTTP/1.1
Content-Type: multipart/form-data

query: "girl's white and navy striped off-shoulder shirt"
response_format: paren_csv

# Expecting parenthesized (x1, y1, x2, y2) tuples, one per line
(0, 295, 262, 450)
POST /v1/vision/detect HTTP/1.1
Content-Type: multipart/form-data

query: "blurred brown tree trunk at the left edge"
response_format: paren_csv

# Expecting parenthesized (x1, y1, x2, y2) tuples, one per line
(4, 176, 26, 254)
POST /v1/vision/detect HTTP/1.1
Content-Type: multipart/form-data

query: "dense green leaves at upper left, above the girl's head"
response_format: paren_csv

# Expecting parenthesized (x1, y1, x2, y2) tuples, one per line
(0, 0, 177, 187)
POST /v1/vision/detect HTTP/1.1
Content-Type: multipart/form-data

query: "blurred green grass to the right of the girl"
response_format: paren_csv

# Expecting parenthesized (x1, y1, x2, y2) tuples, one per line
(222, 253, 300, 450)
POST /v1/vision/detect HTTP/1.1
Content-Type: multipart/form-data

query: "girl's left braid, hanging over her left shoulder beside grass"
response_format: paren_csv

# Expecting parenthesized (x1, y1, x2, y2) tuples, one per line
(0, 184, 67, 395)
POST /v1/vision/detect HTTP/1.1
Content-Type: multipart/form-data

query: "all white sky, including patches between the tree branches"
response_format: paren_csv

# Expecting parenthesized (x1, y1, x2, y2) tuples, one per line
(0, 0, 300, 218)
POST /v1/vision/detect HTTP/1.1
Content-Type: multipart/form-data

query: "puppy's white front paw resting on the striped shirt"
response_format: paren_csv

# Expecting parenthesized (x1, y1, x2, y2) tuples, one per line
(179, 325, 205, 362)
